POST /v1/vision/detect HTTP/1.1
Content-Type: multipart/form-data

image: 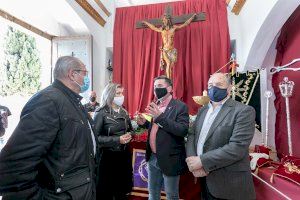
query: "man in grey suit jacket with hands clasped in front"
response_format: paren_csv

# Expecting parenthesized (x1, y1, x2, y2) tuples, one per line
(186, 73, 255, 200)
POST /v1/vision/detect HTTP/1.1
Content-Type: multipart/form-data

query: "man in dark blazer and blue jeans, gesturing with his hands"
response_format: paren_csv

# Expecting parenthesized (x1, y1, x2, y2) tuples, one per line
(138, 76, 189, 200)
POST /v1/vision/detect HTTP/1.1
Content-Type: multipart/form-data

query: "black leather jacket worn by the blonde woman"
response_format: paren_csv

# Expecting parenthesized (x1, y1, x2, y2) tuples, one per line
(94, 106, 132, 151)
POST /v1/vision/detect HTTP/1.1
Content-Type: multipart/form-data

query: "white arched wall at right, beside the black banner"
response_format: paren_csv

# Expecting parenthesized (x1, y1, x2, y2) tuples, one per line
(228, 0, 300, 153)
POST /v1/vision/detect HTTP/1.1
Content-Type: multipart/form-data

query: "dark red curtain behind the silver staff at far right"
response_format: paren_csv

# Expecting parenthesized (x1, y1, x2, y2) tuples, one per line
(272, 7, 300, 157)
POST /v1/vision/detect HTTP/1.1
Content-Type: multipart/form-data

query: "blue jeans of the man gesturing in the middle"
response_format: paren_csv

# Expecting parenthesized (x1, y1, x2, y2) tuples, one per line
(148, 154, 180, 200)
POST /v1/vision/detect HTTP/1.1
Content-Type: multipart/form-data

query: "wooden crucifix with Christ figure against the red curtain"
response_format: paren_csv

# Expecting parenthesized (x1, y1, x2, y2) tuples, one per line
(136, 6, 206, 79)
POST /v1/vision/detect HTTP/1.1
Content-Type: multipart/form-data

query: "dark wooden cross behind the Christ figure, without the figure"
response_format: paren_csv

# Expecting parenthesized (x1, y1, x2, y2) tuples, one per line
(136, 5, 206, 28)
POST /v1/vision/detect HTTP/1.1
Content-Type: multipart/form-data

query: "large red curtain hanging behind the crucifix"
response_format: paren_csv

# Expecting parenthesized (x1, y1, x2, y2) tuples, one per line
(113, 0, 230, 114)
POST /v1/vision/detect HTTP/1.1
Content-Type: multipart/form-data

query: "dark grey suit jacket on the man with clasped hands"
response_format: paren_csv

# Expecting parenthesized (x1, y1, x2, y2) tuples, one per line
(186, 99, 255, 200)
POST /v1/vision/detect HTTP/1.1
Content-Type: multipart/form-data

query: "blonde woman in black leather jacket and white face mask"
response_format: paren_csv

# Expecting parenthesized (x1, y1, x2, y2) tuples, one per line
(94, 83, 132, 200)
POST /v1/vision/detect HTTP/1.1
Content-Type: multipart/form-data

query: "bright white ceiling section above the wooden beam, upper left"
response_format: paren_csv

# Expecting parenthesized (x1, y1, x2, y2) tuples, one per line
(0, 0, 89, 36)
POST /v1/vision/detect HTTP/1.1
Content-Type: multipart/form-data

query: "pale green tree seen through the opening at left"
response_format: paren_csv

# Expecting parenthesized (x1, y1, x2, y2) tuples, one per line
(0, 27, 41, 96)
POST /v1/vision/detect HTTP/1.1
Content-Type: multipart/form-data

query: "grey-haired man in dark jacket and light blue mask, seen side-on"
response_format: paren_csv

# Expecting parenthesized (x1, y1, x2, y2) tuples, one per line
(0, 56, 99, 200)
